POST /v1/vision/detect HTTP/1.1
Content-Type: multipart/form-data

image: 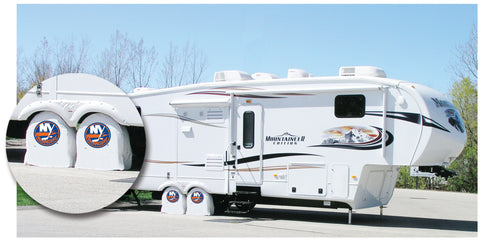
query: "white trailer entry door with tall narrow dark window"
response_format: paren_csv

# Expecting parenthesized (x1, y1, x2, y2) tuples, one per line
(235, 105, 263, 186)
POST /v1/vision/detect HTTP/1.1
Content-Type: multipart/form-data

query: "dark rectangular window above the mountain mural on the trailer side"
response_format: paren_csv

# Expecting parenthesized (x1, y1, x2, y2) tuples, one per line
(335, 95, 365, 118)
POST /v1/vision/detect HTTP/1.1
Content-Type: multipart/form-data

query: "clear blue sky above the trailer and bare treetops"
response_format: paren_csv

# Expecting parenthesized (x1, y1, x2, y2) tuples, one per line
(17, 4, 477, 93)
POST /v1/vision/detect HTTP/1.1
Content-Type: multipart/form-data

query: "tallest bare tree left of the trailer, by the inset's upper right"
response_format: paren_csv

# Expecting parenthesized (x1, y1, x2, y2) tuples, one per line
(96, 30, 130, 89)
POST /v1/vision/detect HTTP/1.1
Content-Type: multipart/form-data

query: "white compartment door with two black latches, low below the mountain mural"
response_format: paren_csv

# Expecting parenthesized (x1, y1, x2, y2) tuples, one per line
(288, 163, 327, 196)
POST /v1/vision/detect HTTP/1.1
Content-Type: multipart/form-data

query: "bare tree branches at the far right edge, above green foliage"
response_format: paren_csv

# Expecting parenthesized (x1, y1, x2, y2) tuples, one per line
(450, 24, 478, 82)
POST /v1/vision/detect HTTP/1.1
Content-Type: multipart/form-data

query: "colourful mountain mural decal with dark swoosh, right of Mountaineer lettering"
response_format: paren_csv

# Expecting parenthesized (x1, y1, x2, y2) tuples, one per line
(310, 126, 393, 150)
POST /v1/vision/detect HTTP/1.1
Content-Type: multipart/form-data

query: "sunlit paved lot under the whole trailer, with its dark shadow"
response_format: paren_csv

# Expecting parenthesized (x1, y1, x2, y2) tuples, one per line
(17, 189, 478, 237)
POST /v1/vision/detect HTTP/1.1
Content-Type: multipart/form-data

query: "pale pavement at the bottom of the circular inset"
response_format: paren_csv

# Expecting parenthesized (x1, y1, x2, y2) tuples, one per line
(9, 163, 139, 213)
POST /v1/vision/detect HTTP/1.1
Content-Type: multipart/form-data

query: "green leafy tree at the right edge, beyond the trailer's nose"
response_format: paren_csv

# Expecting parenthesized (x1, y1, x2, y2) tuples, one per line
(448, 78, 478, 193)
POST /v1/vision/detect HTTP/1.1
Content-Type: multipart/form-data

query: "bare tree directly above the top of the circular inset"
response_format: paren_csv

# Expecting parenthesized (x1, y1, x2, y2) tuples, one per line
(55, 38, 90, 75)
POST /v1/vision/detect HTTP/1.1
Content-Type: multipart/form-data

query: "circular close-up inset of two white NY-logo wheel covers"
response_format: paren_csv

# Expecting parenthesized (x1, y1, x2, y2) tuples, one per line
(6, 74, 146, 214)
